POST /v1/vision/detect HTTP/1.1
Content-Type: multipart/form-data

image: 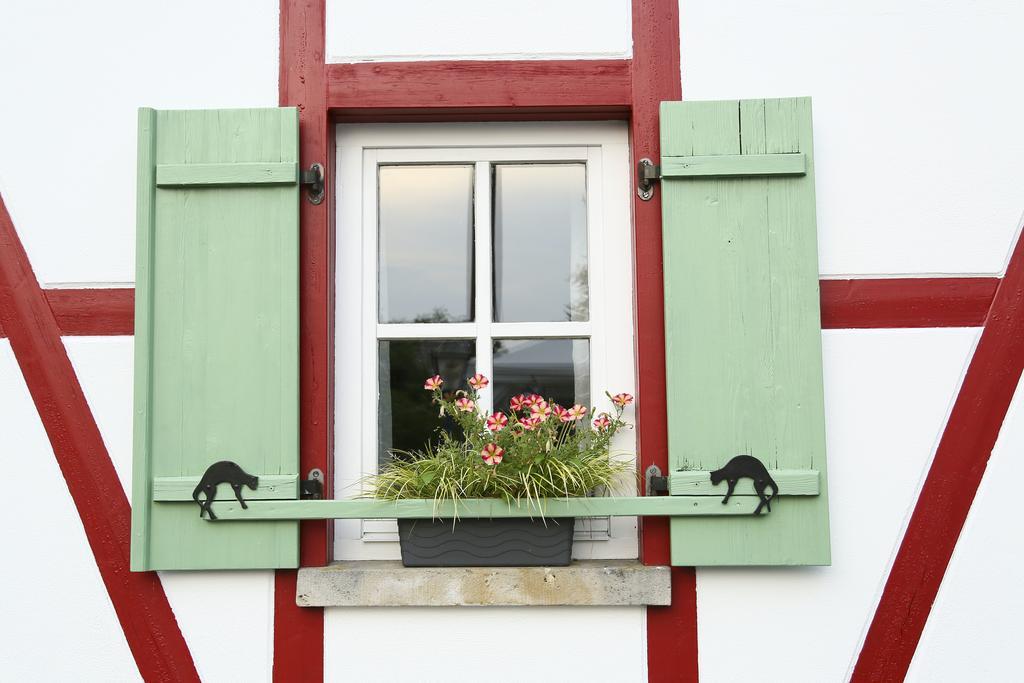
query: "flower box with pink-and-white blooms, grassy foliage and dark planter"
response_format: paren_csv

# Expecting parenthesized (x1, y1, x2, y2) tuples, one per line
(370, 374, 633, 567)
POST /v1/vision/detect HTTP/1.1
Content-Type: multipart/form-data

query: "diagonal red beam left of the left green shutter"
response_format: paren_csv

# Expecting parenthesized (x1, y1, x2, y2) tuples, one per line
(0, 198, 199, 681)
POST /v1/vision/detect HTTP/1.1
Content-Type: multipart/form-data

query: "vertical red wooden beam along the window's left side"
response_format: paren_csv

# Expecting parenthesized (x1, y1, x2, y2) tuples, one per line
(273, 0, 334, 682)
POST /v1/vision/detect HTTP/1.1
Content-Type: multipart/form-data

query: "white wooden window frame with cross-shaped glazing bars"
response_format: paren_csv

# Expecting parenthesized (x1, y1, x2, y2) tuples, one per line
(335, 121, 638, 560)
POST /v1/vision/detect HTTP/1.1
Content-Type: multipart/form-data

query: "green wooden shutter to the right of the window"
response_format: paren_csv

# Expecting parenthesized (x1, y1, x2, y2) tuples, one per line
(662, 98, 830, 566)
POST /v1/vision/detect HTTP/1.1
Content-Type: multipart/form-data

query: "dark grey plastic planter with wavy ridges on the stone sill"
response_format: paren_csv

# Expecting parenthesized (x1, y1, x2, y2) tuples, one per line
(398, 517, 574, 567)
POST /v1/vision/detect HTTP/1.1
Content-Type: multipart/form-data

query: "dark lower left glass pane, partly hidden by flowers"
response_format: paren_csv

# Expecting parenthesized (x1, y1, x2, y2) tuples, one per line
(377, 339, 476, 471)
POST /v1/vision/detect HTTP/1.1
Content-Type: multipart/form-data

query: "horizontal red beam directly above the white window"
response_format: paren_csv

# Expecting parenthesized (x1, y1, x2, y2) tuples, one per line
(327, 59, 632, 121)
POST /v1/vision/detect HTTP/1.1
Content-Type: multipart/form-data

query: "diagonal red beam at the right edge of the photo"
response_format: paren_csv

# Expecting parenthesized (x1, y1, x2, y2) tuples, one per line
(852, 228, 1024, 683)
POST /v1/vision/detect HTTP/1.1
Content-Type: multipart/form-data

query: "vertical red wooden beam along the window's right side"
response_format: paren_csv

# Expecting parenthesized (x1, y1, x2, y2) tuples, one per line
(630, 0, 697, 682)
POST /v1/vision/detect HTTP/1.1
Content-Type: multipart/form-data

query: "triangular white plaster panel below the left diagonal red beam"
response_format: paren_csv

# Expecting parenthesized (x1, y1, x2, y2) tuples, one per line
(0, 339, 140, 683)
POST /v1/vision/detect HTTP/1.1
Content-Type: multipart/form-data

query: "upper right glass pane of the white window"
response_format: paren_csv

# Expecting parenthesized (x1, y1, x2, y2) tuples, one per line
(494, 164, 589, 323)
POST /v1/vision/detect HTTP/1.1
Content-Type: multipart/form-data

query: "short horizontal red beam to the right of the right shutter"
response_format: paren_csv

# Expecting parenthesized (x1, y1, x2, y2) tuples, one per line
(821, 278, 999, 330)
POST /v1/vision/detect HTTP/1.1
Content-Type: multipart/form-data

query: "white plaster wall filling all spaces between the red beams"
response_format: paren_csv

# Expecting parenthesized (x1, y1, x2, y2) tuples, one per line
(0, 0, 1024, 682)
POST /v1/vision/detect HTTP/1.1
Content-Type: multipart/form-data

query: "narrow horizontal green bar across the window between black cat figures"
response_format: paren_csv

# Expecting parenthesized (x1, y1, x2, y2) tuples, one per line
(195, 496, 774, 526)
